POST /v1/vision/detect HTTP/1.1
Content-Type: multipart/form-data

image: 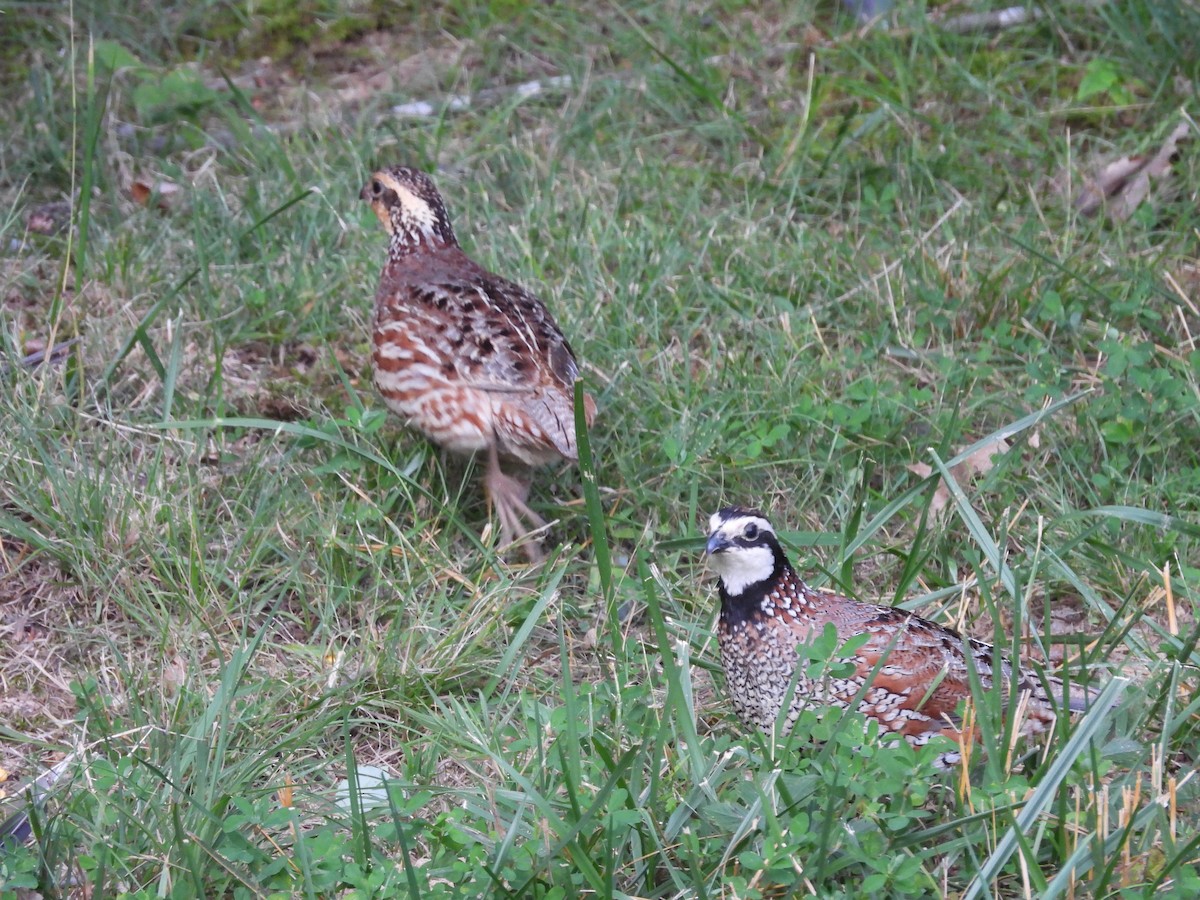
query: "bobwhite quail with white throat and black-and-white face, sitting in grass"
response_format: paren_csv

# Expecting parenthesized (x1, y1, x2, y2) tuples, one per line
(707, 506, 1096, 766)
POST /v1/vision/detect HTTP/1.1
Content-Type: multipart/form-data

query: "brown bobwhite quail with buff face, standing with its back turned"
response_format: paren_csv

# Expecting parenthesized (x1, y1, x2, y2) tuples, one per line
(360, 166, 595, 558)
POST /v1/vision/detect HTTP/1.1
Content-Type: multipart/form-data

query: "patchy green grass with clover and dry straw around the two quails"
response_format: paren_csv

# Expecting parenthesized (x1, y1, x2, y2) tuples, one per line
(0, 0, 1200, 898)
